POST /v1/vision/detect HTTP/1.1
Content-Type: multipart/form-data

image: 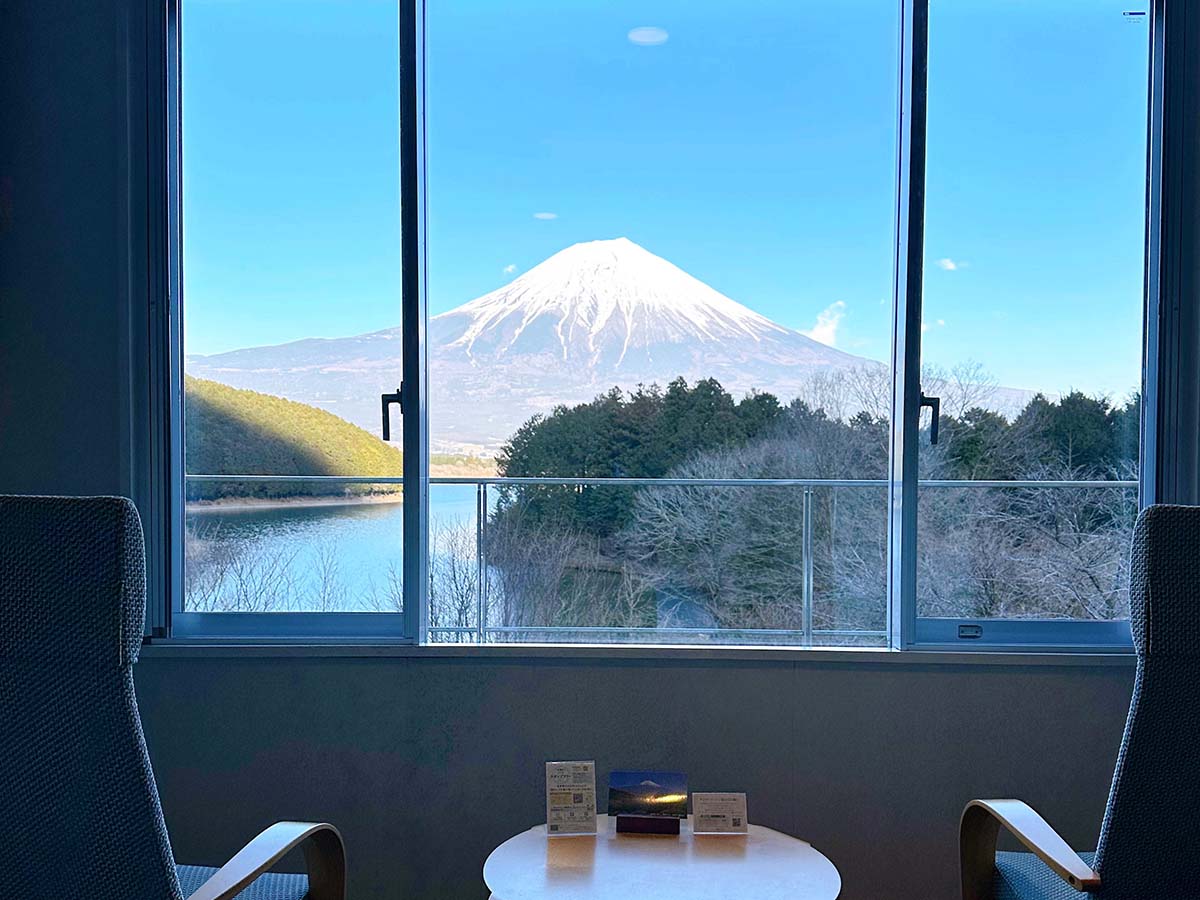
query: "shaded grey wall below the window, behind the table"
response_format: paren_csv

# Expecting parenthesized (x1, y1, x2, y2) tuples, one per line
(137, 650, 1133, 900)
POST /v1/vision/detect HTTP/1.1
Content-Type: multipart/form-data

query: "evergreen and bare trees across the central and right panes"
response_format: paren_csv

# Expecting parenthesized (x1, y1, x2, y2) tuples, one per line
(487, 376, 1140, 632)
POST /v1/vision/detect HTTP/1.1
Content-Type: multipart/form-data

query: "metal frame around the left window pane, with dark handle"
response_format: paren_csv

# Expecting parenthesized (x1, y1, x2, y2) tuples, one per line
(162, 0, 430, 643)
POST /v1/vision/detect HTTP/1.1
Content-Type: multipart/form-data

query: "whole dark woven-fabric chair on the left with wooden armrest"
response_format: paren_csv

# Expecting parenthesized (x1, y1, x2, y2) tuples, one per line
(0, 497, 346, 900)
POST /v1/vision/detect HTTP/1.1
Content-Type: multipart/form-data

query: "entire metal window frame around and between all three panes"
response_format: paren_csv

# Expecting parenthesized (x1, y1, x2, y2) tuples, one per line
(154, 0, 1176, 653)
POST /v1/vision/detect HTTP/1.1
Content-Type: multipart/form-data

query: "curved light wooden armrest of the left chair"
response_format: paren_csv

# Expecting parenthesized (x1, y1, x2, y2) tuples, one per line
(187, 822, 346, 900)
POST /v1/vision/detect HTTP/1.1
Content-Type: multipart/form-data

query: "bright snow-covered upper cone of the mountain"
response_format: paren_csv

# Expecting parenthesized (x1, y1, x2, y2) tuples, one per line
(432, 238, 788, 367)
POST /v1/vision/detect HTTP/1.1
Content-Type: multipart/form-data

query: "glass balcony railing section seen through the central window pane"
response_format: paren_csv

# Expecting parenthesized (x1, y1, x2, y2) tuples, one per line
(430, 480, 887, 646)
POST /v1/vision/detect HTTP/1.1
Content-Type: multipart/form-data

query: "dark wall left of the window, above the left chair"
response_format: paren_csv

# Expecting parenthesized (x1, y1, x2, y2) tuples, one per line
(0, 0, 132, 493)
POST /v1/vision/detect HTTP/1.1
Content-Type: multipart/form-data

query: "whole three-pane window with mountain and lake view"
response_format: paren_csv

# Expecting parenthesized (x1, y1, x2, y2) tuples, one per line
(172, 0, 1150, 648)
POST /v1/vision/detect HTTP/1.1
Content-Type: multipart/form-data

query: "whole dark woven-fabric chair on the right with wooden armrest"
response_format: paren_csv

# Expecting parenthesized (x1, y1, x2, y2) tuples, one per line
(960, 506, 1200, 900)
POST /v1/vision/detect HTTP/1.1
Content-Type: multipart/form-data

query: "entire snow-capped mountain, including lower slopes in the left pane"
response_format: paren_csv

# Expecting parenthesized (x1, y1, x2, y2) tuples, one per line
(186, 238, 882, 452)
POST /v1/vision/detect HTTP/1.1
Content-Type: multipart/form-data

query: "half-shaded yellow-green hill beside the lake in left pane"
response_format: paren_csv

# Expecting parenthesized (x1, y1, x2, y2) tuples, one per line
(184, 377, 403, 500)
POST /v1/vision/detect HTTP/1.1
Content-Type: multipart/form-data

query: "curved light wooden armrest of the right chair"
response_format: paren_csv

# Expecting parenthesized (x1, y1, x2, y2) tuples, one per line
(959, 800, 1100, 900)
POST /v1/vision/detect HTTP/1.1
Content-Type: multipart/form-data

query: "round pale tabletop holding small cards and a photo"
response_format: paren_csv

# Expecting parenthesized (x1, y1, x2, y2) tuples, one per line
(484, 816, 841, 900)
